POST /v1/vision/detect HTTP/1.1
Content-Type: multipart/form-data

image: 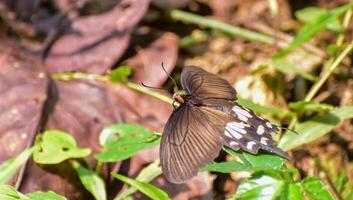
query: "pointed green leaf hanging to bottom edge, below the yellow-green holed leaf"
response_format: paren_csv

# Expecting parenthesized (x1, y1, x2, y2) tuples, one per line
(71, 160, 107, 200)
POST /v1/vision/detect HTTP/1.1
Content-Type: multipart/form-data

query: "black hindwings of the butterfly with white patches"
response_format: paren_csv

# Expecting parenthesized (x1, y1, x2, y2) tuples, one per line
(201, 99, 288, 159)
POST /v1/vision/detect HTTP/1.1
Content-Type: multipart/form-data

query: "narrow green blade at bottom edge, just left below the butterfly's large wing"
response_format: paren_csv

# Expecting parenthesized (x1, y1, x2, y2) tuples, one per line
(111, 173, 170, 200)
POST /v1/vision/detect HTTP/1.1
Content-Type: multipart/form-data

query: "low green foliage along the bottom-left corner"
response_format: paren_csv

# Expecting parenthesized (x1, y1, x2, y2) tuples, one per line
(0, 185, 66, 200)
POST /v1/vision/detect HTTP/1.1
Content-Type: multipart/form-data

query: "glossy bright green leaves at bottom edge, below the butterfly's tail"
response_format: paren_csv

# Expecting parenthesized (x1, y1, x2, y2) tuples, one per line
(231, 170, 334, 200)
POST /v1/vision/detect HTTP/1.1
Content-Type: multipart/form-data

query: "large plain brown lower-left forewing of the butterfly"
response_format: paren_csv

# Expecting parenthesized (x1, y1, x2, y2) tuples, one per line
(160, 104, 222, 183)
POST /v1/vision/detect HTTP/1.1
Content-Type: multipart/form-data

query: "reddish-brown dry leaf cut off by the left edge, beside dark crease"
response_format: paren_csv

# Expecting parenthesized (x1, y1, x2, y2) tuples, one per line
(0, 48, 48, 163)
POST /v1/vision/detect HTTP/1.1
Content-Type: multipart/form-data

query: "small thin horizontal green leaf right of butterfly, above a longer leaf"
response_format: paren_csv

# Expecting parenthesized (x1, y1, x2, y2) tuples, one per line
(288, 101, 334, 113)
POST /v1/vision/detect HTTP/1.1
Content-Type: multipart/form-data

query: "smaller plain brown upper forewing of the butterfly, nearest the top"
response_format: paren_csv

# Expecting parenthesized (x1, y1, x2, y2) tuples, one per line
(181, 66, 236, 100)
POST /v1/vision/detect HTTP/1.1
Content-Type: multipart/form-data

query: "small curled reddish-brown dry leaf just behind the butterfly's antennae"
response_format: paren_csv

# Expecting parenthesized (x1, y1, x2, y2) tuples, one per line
(125, 33, 178, 86)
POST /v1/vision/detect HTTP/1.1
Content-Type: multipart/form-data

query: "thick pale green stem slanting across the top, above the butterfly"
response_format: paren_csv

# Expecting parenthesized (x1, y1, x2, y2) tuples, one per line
(170, 10, 274, 44)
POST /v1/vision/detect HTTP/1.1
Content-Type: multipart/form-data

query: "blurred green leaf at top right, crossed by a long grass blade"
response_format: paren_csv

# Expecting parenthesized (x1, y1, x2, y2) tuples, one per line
(295, 7, 344, 32)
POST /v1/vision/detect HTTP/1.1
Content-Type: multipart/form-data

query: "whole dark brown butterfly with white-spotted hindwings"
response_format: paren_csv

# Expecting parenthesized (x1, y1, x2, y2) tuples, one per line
(160, 66, 288, 183)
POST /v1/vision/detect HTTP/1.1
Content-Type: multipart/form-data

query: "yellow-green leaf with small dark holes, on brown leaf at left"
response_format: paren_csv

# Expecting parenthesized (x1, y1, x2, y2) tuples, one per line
(33, 130, 91, 164)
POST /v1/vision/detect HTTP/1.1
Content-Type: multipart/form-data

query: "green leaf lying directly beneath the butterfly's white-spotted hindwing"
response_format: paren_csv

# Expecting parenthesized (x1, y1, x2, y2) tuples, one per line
(200, 147, 286, 173)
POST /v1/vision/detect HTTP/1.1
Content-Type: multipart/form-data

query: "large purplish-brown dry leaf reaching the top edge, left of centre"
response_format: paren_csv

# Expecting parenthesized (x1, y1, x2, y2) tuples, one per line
(45, 0, 149, 73)
